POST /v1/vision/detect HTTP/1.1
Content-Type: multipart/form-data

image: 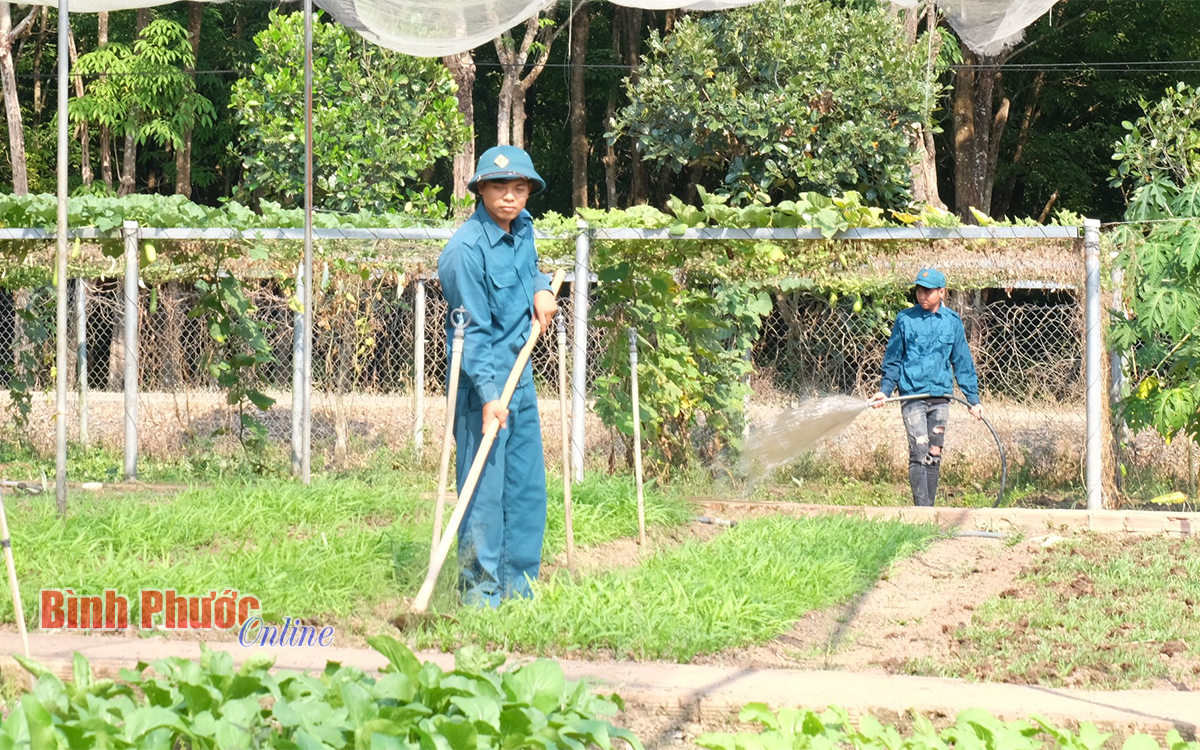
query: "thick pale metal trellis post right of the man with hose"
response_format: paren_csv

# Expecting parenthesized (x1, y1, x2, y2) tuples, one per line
(1084, 218, 1104, 510)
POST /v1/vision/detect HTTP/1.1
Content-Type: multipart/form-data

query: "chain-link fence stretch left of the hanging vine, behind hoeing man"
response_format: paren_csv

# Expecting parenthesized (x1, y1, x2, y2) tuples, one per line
(0, 256, 600, 464)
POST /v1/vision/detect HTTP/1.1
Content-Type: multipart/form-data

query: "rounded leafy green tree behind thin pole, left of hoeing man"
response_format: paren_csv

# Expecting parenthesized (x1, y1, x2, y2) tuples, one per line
(230, 12, 467, 211)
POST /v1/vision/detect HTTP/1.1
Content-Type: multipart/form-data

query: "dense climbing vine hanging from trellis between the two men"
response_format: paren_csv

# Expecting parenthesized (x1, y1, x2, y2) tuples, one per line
(571, 194, 781, 475)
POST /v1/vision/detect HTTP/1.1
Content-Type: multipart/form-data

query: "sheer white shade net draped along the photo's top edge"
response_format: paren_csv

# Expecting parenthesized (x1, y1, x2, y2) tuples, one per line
(16, 0, 1056, 58)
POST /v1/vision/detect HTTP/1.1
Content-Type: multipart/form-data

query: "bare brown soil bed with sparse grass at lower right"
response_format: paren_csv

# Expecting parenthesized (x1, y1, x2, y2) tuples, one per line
(697, 534, 1200, 690)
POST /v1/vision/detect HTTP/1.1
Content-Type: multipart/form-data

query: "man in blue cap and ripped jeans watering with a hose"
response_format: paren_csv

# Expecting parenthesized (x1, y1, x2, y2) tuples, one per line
(869, 269, 983, 505)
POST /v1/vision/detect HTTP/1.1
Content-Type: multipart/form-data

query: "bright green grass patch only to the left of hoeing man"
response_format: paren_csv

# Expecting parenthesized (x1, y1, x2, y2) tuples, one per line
(7, 480, 428, 622)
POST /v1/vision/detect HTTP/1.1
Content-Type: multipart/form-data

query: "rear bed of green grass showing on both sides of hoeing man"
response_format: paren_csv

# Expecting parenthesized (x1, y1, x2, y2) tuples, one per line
(0, 468, 692, 629)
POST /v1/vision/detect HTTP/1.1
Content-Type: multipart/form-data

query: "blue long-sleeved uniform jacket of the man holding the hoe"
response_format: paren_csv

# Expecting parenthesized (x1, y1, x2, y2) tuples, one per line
(438, 204, 550, 404)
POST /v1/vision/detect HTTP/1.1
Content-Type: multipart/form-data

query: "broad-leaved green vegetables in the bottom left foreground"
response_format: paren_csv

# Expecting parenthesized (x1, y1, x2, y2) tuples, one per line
(0, 636, 642, 750)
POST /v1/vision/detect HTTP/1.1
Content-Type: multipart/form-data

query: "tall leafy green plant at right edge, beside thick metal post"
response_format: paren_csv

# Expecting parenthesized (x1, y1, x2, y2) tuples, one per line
(1111, 84, 1200, 440)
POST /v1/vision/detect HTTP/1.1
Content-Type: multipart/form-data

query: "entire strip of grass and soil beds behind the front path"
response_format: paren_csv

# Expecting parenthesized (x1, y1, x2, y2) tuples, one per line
(0, 474, 1200, 690)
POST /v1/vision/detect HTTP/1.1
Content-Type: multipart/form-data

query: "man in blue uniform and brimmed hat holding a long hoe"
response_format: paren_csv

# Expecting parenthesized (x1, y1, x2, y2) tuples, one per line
(438, 146, 558, 607)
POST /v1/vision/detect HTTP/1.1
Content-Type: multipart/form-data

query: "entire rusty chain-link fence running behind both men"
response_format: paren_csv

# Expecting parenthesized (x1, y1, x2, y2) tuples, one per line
(0, 232, 1195, 504)
